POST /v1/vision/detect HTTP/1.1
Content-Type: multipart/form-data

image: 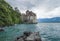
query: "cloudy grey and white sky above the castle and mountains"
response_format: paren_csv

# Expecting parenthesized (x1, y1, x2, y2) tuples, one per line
(6, 0, 60, 18)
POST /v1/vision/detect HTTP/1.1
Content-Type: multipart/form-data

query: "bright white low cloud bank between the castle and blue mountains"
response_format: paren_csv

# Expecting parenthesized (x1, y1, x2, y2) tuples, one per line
(32, 6, 60, 18)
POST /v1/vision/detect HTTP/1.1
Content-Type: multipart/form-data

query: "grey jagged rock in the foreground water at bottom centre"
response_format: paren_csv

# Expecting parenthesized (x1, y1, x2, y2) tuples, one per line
(16, 32, 42, 41)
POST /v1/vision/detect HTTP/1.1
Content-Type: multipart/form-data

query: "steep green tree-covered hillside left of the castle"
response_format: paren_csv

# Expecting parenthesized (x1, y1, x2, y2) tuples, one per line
(0, 0, 21, 26)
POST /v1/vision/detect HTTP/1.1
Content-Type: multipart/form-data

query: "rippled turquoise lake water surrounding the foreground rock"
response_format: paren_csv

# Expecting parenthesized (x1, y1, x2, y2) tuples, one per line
(0, 23, 60, 41)
